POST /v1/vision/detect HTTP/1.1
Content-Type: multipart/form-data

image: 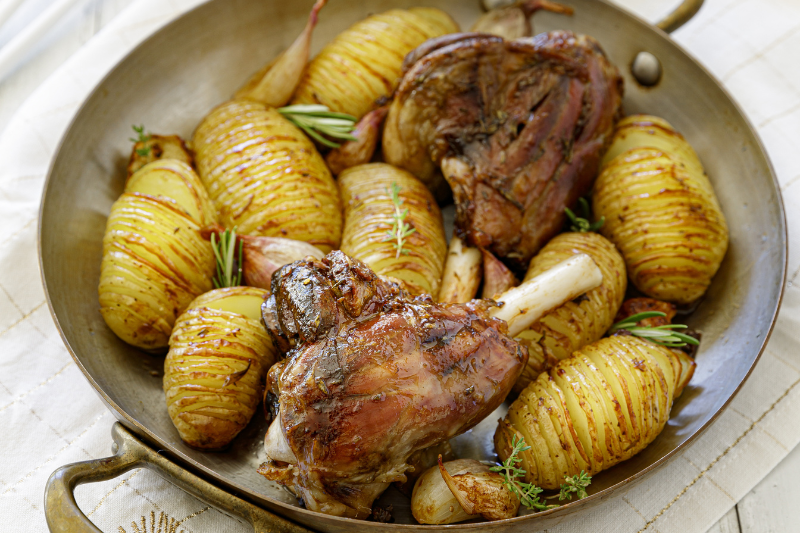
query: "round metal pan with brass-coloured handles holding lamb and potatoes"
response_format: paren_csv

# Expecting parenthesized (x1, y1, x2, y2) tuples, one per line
(39, 0, 787, 533)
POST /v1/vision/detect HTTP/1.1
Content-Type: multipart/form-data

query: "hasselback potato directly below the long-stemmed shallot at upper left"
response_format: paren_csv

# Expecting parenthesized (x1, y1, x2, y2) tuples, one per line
(194, 100, 342, 252)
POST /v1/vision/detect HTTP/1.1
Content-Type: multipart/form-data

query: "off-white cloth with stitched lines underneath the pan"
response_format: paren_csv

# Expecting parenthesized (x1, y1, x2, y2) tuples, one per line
(0, 0, 800, 533)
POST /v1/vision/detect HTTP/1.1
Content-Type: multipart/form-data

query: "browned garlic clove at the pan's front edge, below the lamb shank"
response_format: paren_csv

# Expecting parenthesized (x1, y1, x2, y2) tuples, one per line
(411, 456, 520, 525)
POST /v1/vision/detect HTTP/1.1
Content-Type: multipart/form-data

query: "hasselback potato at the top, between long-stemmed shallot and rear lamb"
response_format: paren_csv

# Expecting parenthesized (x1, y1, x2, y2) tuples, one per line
(292, 7, 458, 118)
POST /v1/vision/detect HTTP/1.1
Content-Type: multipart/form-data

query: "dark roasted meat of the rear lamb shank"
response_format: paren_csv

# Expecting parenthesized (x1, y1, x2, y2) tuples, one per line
(383, 31, 623, 271)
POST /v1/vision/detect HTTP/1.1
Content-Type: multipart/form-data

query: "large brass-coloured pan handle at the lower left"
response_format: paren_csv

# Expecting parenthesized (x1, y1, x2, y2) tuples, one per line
(44, 422, 311, 533)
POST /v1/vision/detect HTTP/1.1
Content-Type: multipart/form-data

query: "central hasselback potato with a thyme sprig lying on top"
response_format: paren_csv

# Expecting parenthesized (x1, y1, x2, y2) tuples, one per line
(339, 163, 447, 295)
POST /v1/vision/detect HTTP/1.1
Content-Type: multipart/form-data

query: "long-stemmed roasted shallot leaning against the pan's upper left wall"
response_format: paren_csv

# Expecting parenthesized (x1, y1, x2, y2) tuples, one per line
(235, 0, 328, 107)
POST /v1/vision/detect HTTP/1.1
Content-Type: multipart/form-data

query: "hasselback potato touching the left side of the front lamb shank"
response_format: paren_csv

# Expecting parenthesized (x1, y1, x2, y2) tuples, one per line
(164, 287, 277, 450)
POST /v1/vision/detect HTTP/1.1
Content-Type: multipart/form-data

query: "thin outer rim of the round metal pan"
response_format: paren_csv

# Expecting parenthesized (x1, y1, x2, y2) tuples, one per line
(37, 0, 789, 531)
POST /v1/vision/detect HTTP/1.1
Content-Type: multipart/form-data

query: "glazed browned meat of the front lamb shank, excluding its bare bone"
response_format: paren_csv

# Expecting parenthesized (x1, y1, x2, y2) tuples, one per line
(259, 251, 527, 518)
